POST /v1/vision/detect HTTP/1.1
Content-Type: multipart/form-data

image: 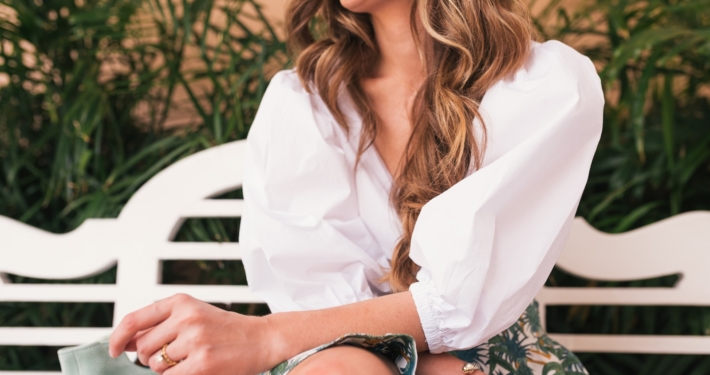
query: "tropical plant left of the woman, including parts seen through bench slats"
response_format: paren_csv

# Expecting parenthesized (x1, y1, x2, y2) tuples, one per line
(0, 0, 286, 370)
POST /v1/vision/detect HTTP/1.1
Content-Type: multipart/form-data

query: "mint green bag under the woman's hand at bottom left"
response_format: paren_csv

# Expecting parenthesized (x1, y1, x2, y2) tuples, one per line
(57, 338, 155, 375)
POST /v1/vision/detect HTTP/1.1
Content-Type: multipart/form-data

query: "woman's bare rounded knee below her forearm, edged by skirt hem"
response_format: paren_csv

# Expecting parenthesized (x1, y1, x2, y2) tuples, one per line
(289, 345, 399, 375)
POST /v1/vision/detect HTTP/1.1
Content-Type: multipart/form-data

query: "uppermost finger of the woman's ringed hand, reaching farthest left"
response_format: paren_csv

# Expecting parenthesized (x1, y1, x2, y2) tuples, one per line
(108, 295, 189, 358)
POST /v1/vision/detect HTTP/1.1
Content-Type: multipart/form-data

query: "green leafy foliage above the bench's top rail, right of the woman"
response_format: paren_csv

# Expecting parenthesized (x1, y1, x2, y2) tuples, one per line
(538, 0, 710, 232)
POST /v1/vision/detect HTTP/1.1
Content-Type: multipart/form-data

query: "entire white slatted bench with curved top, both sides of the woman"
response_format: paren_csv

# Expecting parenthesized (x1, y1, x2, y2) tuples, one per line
(0, 141, 710, 375)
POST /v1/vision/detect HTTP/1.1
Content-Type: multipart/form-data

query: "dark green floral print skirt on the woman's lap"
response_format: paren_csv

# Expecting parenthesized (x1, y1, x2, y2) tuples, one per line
(261, 302, 589, 375)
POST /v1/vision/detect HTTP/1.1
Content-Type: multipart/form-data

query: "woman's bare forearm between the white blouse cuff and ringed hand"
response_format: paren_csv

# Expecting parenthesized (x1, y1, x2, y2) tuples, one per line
(265, 292, 428, 361)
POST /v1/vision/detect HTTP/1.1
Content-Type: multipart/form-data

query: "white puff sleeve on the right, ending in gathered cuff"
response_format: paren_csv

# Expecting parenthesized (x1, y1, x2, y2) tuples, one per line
(410, 42, 604, 353)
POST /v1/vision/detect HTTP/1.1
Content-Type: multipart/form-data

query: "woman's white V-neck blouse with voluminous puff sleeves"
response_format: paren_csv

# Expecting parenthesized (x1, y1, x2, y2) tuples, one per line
(240, 41, 604, 353)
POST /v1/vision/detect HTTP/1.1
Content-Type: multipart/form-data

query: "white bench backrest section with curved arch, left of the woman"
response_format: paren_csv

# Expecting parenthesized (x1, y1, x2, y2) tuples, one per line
(0, 142, 253, 375)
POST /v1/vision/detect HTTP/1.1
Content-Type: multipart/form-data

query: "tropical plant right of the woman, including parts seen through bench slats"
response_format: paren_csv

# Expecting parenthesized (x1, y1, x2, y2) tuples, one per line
(533, 0, 710, 375)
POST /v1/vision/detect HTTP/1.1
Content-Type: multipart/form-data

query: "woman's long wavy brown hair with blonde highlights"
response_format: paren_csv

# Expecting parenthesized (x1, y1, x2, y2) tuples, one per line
(286, 0, 534, 292)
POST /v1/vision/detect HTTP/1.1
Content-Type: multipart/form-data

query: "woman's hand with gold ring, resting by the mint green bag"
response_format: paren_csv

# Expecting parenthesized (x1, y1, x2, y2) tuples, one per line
(109, 294, 280, 375)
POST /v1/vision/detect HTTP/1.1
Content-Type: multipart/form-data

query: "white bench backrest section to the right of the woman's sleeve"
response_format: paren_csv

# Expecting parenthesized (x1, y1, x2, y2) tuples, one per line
(537, 211, 710, 354)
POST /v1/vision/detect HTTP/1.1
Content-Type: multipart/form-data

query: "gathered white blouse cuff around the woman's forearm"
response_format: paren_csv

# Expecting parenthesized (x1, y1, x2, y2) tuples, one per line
(409, 282, 446, 353)
